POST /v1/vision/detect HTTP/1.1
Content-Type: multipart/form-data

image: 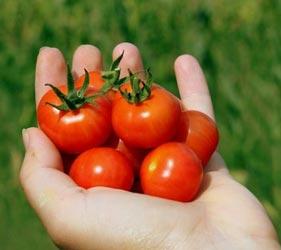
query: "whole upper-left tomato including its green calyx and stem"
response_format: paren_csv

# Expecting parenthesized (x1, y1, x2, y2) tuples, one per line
(37, 54, 123, 154)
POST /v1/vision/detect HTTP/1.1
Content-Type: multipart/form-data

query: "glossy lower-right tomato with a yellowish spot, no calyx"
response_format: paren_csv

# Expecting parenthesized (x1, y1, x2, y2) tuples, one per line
(140, 142, 203, 202)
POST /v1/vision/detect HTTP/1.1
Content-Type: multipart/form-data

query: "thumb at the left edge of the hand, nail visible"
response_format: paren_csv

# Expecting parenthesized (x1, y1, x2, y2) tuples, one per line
(20, 128, 77, 225)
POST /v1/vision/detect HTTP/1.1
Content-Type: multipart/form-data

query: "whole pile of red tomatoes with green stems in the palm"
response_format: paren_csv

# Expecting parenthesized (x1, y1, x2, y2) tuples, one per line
(37, 55, 218, 201)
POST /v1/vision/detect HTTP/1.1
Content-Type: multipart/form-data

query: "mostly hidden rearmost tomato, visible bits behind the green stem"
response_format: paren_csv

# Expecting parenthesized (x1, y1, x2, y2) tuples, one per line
(75, 71, 115, 101)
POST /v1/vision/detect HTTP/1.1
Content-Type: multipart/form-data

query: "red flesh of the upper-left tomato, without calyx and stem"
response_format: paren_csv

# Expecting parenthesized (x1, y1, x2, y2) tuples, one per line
(37, 86, 112, 154)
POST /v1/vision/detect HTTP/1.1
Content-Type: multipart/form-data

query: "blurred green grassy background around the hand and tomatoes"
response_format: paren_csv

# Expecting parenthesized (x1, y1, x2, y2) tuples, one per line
(0, 0, 281, 250)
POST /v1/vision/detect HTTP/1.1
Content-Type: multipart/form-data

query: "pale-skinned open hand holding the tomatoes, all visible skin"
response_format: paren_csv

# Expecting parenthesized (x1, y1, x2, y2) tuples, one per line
(20, 43, 281, 250)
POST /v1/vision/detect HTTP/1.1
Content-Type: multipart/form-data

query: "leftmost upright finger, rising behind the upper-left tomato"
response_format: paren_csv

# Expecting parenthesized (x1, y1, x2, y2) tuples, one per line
(35, 47, 66, 106)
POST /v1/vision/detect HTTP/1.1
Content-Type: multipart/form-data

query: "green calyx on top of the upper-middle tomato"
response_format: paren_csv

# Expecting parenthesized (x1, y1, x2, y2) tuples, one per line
(119, 69, 152, 104)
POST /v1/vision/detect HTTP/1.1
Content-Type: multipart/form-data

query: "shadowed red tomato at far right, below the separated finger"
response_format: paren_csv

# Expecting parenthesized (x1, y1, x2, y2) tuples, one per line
(177, 110, 219, 166)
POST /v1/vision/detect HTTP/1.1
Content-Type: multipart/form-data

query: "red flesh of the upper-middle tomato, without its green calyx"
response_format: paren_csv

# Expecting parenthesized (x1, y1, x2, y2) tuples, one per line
(112, 87, 181, 149)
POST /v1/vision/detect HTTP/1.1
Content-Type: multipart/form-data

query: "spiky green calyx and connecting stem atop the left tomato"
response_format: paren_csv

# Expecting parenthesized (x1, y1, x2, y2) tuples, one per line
(45, 52, 124, 111)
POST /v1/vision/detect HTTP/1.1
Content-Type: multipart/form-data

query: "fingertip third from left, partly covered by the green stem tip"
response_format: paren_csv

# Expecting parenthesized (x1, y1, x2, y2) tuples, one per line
(112, 43, 143, 77)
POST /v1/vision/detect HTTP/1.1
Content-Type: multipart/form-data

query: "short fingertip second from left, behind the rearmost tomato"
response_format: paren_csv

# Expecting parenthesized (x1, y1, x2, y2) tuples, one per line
(72, 44, 102, 79)
